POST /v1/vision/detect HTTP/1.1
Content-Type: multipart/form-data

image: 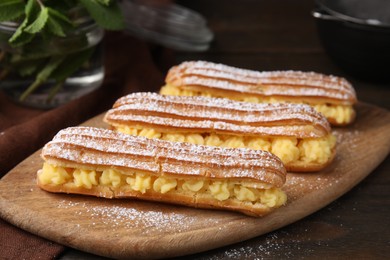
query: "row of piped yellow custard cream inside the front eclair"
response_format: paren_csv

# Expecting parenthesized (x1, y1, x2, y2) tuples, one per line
(38, 163, 287, 207)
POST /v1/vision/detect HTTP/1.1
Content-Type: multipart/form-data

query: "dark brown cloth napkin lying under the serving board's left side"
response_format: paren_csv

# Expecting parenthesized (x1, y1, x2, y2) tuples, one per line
(0, 33, 173, 259)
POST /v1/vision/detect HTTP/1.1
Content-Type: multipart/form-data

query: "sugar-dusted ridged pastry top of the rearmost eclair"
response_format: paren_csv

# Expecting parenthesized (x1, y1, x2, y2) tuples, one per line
(166, 61, 356, 105)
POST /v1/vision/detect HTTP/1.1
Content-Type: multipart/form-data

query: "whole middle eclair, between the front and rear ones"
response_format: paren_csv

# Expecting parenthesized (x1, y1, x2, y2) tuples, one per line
(103, 93, 336, 172)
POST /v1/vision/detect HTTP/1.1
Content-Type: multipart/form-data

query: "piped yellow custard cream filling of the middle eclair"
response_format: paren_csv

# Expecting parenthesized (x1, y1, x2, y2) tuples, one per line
(117, 126, 336, 167)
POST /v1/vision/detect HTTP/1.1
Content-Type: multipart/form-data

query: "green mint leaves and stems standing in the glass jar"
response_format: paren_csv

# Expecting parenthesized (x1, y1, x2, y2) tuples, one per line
(0, 0, 125, 103)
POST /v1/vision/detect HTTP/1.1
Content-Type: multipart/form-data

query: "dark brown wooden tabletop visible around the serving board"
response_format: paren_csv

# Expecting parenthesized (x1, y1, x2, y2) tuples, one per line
(59, 0, 390, 259)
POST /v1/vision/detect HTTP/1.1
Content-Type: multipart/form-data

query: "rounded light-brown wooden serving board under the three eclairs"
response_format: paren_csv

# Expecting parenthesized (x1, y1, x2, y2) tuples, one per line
(0, 104, 390, 259)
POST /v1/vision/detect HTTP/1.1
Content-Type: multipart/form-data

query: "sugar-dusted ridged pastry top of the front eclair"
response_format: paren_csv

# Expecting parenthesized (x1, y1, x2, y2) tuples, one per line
(41, 127, 286, 187)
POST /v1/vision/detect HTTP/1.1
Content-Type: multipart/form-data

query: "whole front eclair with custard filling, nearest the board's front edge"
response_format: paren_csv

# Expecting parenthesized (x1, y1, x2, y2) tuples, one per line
(37, 127, 287, 216)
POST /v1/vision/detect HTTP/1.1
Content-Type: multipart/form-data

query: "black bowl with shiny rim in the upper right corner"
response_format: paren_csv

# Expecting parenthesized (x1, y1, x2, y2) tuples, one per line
(312, 0, 390, 83)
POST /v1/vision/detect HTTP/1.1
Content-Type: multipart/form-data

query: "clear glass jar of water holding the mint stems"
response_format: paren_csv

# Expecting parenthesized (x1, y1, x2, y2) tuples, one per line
(0, 9, 104, 108)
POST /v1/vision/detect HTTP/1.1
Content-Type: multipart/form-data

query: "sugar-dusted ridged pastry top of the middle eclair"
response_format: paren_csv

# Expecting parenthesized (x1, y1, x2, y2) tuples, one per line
(104, 93, 330, 138)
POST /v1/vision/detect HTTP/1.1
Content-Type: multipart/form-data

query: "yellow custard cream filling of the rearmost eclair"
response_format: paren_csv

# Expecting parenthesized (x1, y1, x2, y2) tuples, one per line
(160, 84, 354, 124)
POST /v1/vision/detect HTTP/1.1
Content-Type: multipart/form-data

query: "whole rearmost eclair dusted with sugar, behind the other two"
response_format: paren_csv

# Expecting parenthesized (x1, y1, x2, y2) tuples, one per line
(160, 61, 357, 126)
